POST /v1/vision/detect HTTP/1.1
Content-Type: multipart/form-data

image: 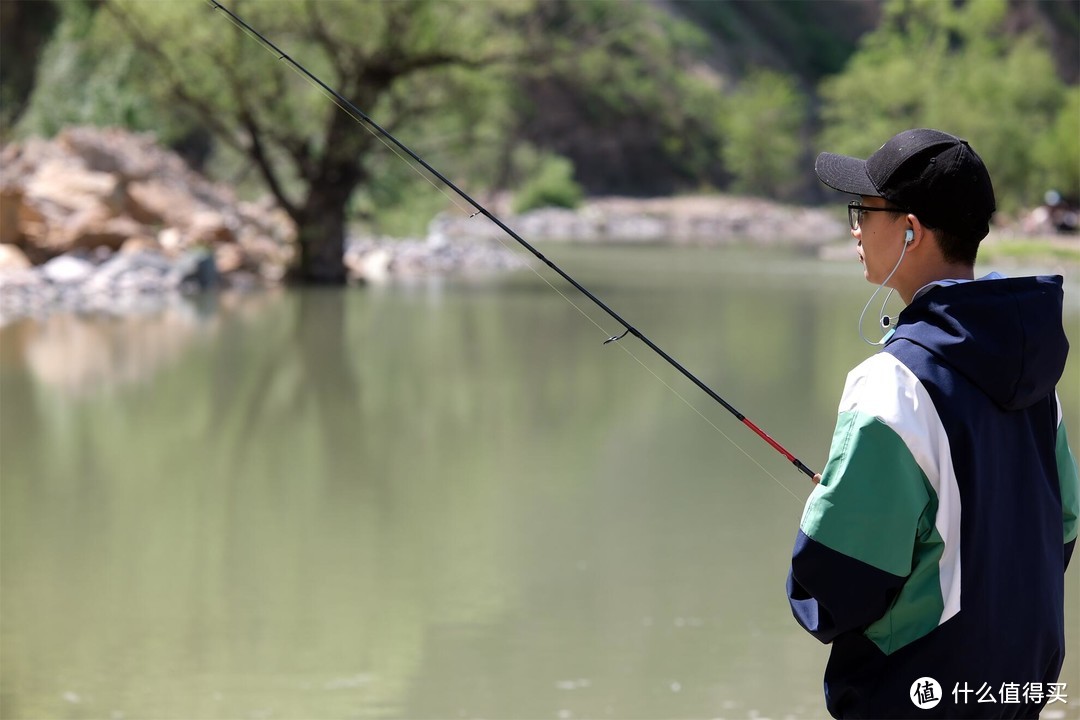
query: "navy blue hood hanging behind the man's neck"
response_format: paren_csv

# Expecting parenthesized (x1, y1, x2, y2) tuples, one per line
(886, 275, 1069, 410)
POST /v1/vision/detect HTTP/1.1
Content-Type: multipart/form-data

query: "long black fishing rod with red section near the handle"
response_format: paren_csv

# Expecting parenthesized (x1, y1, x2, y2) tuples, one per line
(207, 0, 814, 479)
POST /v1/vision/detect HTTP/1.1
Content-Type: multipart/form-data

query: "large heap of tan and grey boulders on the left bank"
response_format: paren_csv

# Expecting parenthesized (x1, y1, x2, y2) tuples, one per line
(0, 127, 295, 321)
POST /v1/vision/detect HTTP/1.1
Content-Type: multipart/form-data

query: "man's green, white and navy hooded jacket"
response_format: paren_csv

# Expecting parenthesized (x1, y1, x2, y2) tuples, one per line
(787, 276, 1078, 718)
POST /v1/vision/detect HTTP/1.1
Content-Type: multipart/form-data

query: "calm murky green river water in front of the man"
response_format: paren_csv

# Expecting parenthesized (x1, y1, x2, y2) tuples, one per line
(6, 246, 1080, 720)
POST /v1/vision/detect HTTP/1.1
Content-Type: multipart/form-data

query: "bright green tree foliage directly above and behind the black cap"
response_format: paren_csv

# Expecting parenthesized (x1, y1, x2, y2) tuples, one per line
(820, 0, 1077, 210)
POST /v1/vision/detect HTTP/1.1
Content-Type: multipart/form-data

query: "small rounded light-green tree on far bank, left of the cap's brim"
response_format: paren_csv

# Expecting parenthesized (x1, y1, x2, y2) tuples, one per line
(720, 70, 807, 198)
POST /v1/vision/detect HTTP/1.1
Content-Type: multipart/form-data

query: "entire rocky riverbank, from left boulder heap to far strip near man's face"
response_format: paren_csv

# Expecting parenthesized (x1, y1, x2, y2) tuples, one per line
(6, 127, 1071, 323)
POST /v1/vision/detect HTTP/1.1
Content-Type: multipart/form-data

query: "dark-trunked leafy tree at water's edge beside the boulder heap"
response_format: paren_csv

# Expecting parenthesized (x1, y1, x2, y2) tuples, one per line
(97, 0, 517, 283)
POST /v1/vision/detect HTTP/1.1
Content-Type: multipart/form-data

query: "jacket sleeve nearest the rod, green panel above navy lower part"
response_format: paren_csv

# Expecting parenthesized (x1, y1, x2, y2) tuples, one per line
(787, 358, 935, 642)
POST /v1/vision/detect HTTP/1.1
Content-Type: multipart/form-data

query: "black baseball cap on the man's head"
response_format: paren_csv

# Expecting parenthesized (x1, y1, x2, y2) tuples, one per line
(814, 128, 997, 242)
